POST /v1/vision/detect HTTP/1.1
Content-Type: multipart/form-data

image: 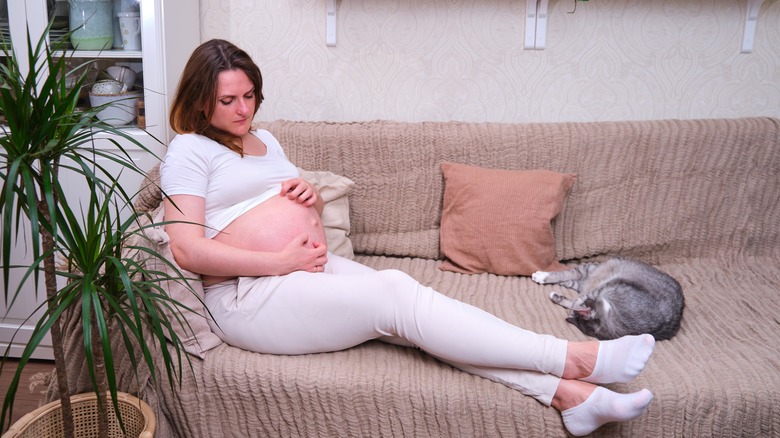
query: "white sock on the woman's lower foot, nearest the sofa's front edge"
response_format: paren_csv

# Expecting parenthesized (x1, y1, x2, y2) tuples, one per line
(561, 386, 653, 436)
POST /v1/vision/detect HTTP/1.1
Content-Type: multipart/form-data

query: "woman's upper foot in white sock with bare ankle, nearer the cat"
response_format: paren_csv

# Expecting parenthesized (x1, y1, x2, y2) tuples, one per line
(562, 334, 655, 383)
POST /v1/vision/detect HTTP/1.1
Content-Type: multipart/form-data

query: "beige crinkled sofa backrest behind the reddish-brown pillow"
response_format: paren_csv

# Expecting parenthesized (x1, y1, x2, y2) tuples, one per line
(260, 118, 780, 260)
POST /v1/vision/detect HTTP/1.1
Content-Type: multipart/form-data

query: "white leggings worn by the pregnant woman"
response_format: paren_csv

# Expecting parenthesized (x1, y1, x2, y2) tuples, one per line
(205, 253, 567, 405)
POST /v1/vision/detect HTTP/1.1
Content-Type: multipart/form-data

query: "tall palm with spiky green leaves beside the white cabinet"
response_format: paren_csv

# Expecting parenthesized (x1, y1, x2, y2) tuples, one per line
(0, 18, 189, 436)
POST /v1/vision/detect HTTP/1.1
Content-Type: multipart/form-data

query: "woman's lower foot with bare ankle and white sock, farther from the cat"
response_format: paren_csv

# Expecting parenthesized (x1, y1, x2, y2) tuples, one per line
(552, 379, 653, 436)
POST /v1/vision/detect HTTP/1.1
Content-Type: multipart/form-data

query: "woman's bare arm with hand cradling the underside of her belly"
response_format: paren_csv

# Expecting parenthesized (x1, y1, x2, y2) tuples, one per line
(164, 193, 327, 277)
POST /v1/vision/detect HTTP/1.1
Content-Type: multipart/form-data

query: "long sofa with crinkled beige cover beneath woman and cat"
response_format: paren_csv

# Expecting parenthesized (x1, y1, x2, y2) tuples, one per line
(45, 117, 780, 437)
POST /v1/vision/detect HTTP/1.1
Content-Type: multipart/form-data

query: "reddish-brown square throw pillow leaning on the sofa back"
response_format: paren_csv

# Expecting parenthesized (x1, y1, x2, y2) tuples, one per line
(439, 163, 575, 275)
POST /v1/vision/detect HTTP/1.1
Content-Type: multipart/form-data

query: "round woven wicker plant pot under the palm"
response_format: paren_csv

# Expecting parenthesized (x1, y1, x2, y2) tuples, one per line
(2, 392, 156, 438)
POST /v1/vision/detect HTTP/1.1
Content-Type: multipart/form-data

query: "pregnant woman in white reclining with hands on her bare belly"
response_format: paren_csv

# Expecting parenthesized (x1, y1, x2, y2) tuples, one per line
(161, 40, 655, 435)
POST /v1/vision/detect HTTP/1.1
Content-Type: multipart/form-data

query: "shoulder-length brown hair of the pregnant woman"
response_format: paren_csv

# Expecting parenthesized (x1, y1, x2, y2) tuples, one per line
(170, 39, 263, 156)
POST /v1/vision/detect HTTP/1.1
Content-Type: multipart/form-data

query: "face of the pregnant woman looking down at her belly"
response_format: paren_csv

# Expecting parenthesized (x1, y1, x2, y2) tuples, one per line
(210, 70, 255, 137)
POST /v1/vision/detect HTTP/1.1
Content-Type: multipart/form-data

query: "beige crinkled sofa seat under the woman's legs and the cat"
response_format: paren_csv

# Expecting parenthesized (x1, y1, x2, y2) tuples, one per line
(142, 255, 780, 437)
